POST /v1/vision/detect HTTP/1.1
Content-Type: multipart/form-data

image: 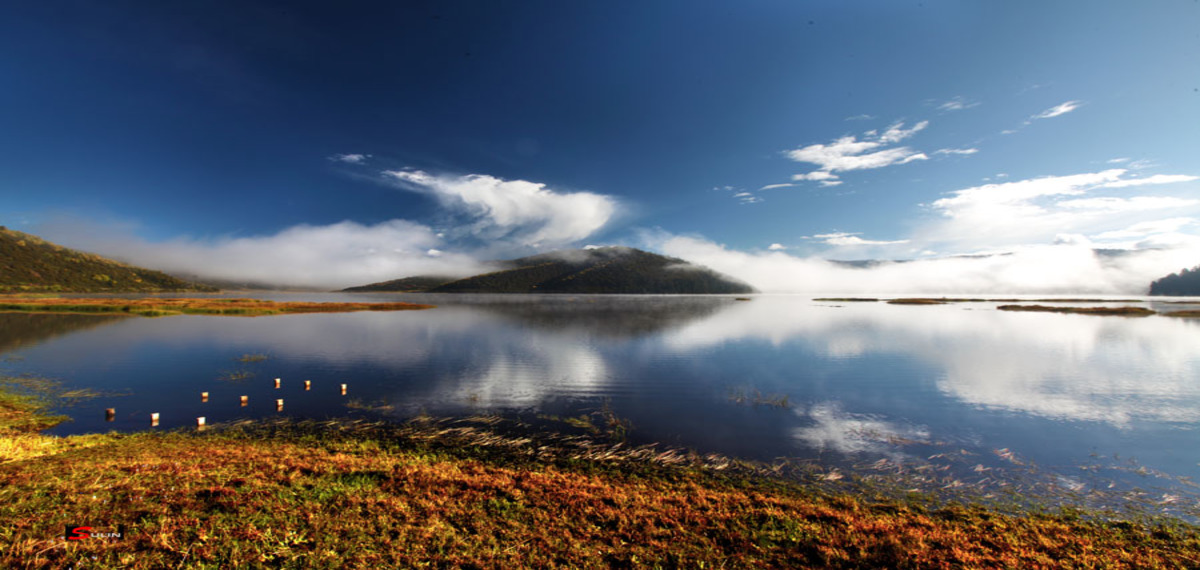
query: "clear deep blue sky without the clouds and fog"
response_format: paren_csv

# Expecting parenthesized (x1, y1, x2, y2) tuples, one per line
(0, 1, 1200, 261)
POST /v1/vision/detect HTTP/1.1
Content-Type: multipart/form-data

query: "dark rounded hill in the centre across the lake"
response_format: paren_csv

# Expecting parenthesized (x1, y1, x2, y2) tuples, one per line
(346, 247, 754, 294)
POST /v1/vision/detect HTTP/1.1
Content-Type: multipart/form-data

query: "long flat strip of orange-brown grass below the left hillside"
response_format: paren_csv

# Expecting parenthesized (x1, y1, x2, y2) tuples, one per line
(0, 296, 433, 317)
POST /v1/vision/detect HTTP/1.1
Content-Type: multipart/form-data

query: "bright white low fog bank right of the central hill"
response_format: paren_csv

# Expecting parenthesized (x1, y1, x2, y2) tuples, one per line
(655, 236, 1200, 295)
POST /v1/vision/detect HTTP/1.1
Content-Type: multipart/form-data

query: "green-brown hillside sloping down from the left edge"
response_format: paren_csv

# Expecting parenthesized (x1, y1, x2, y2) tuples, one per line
(0, 226, 216, 293)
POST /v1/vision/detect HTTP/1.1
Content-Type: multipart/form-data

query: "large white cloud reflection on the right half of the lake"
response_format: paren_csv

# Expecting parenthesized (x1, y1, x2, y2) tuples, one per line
(665, 296, 1200, 426)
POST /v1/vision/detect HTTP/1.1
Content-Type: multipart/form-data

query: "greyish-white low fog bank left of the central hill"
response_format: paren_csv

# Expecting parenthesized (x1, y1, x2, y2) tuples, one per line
(40, 220, 484, 289)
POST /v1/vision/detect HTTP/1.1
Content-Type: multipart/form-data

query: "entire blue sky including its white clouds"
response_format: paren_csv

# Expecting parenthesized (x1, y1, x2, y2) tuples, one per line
(0, 1, 1200, 290)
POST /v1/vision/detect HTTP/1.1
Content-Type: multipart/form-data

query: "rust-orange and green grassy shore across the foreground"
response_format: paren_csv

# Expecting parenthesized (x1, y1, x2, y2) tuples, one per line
(0, 381, 1200, 568)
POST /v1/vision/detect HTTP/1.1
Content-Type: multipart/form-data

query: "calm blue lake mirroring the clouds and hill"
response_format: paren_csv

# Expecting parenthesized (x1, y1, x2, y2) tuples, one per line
(0, 294, 1200, 510)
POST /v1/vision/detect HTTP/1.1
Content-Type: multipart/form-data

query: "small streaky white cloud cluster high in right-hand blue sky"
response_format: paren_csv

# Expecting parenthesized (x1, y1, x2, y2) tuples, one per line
(787, 121, 929, 181)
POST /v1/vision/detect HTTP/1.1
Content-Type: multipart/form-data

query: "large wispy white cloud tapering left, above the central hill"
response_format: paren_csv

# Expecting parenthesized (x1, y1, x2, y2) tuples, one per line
(383, 170, 617, 247)
